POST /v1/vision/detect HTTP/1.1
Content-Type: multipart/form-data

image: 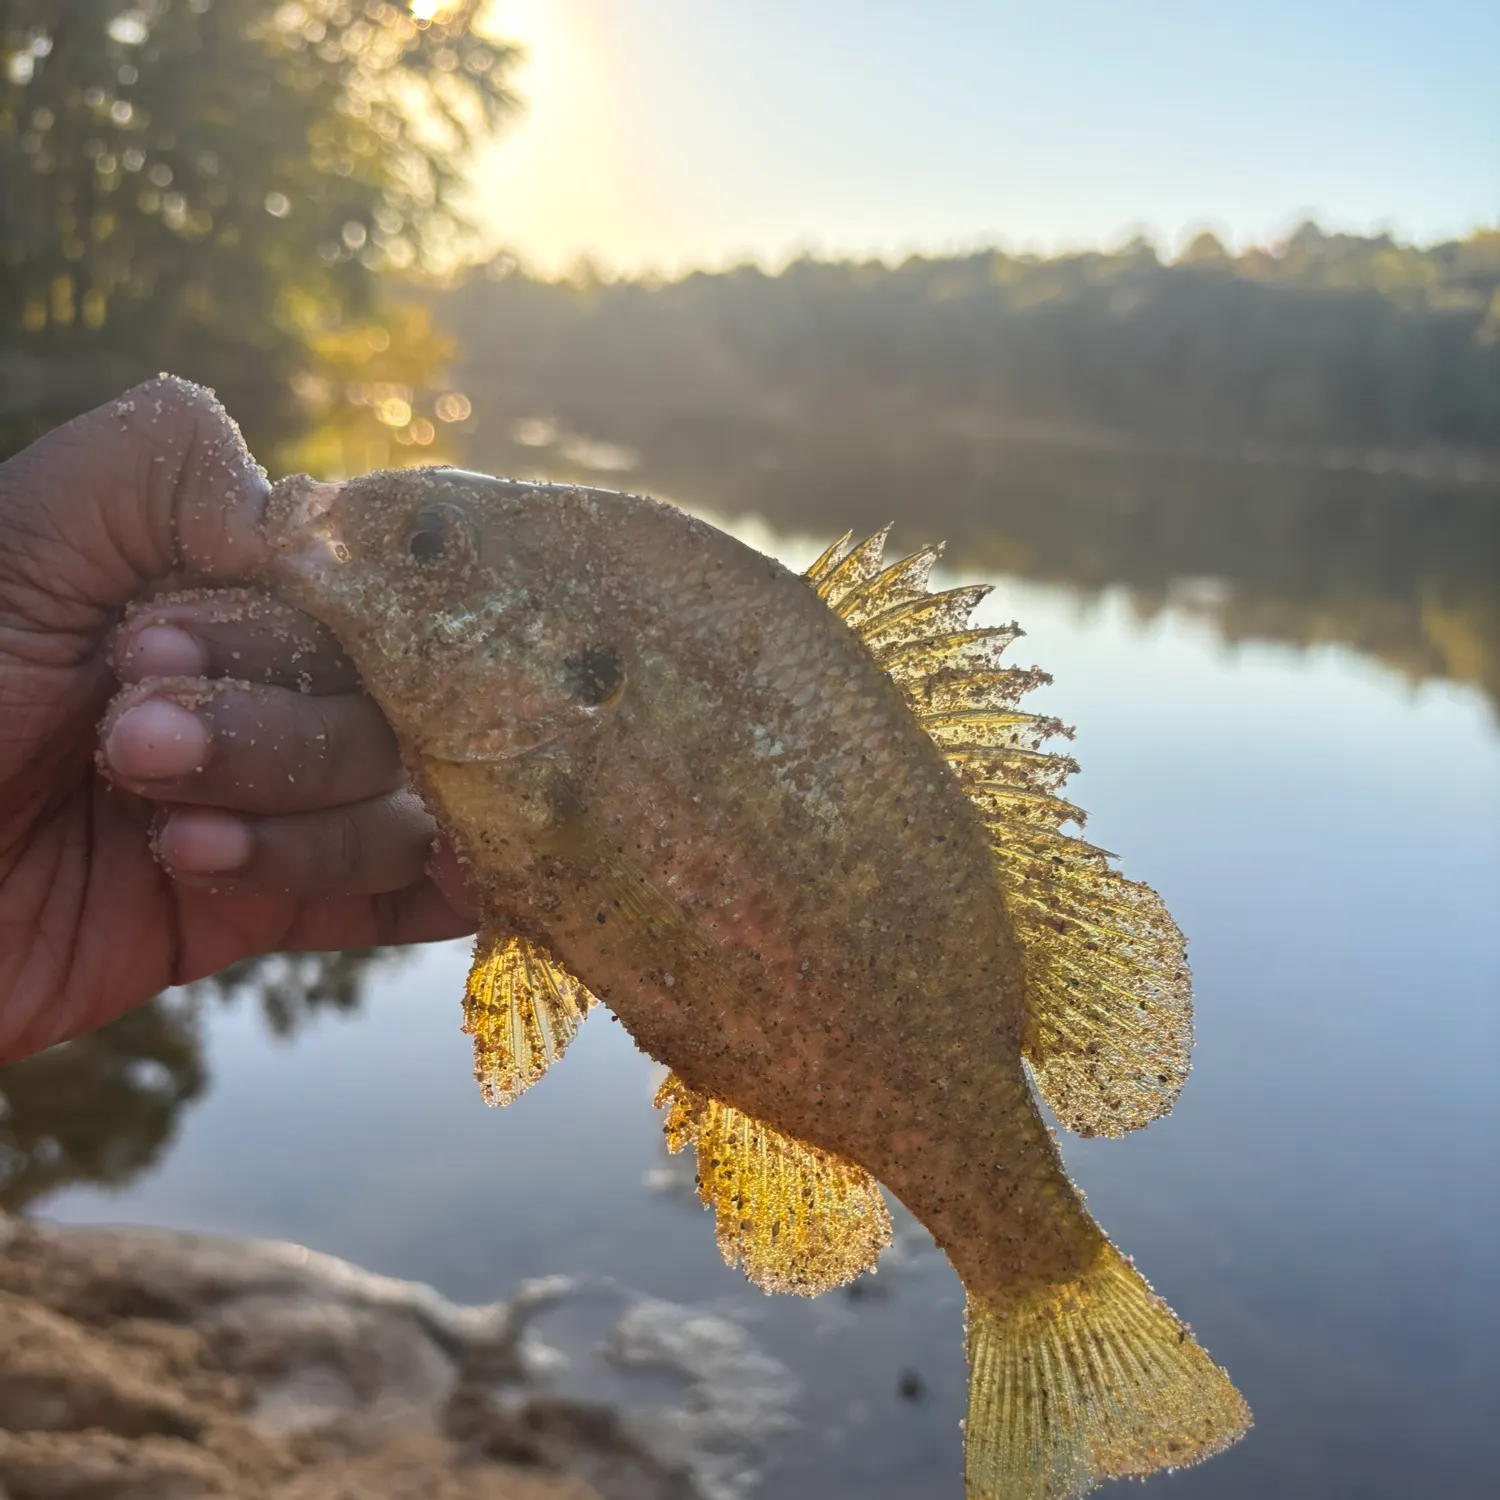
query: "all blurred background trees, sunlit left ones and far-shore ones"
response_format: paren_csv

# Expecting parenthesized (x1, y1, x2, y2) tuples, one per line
(0, 0, 1500, 480)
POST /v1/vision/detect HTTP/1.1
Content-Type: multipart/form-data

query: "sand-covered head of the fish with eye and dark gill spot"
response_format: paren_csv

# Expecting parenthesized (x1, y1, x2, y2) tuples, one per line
(267, 468, 641, 761)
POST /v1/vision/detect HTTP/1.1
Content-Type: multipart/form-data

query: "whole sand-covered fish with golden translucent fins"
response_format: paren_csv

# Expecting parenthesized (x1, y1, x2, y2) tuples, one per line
(266, 468, 1250, 1500)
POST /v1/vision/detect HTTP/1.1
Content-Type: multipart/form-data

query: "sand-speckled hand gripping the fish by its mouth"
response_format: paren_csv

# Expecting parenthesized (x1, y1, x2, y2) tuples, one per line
(0, 380, 473, 1062)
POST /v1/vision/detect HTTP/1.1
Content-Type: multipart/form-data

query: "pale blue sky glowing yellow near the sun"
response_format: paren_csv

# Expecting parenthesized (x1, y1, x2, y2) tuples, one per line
(474, 0, 1500, 273)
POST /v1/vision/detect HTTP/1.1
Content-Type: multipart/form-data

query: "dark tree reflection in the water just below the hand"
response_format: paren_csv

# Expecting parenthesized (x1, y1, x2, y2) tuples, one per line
(0, 948, 389, 1212)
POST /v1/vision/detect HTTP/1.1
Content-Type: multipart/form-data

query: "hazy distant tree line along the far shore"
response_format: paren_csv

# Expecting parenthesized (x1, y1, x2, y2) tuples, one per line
(435, 224, 1500, 456)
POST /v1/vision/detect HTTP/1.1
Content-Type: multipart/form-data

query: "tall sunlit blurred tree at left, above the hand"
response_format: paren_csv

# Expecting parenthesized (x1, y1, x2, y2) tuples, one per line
(0, 0, 515, 455)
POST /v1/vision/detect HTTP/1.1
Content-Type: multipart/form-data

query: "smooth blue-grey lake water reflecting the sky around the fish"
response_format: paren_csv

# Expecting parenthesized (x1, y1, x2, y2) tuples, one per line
(11, 510, 1500, 1500)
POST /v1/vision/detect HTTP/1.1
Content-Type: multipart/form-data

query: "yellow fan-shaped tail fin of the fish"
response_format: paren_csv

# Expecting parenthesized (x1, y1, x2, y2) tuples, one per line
(965, 1242, 1250, 1500)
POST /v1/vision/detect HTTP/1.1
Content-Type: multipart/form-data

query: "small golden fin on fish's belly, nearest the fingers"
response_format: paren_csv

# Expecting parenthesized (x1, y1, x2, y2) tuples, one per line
(464, 927, 594, 1104)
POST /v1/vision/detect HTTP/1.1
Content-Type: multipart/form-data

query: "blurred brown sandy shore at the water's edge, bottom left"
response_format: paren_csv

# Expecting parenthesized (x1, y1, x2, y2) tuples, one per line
(0, 1217, 791, 1500)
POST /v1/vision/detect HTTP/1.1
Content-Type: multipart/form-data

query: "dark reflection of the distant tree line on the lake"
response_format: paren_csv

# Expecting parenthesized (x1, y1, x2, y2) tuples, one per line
(467, 413, 1500, 711)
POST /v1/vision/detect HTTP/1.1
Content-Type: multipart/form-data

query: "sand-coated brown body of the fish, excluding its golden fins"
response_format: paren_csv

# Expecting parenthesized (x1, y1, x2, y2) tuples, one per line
(269, 470, 1238, 1496)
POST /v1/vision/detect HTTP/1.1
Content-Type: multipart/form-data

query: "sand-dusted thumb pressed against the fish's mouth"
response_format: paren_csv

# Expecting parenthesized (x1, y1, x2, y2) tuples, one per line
(0, 377, 269, 635)
